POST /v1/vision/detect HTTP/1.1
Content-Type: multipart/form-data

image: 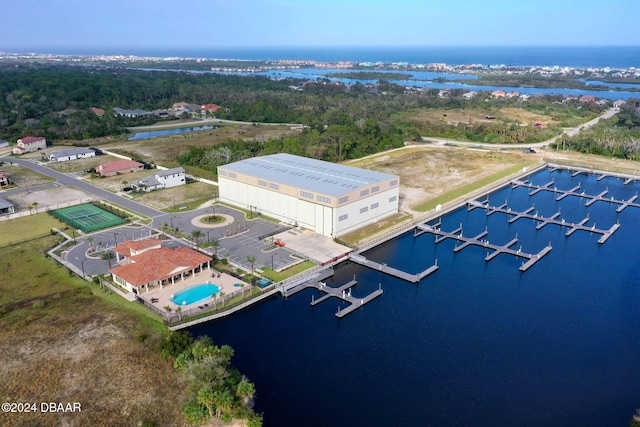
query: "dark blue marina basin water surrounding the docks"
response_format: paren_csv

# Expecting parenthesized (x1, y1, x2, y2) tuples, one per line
(192, 170, 640, 427)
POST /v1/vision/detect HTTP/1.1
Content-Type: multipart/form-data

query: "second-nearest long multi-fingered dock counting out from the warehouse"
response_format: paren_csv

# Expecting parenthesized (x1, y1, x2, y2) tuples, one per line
(467, 200, 620, 244)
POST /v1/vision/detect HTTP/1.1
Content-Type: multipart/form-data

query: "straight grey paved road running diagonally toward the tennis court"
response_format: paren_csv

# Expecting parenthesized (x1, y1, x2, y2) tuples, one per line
(0, 157, 164, 218)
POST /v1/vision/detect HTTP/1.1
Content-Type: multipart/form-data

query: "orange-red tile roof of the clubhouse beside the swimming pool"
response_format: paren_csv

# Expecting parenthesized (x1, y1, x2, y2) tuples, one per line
(109, 246, 211, 287)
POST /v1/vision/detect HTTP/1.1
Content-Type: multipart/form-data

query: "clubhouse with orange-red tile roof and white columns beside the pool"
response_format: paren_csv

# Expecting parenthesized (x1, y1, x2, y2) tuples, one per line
(109, 238, 211, 294)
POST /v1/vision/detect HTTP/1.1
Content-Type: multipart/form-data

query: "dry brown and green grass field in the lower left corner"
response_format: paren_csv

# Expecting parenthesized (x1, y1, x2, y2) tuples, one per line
(0, 237, 184, 427)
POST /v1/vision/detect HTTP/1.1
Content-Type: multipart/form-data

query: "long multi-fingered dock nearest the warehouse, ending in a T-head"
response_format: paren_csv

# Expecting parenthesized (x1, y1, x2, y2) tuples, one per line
(416, 223, 551, 271)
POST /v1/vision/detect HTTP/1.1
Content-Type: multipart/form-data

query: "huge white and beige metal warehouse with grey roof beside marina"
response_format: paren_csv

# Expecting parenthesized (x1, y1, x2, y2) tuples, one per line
(218, 153, 400, 237)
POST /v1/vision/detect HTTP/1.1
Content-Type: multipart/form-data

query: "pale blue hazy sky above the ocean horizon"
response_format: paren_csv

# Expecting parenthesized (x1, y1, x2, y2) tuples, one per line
(0, 0, 640, 53)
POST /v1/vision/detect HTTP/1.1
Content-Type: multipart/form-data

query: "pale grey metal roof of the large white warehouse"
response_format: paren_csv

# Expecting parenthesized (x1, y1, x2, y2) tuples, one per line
(220, 153, 398, 196)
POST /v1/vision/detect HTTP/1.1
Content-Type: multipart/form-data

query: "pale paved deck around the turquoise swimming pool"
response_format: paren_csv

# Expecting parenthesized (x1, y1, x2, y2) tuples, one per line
(140, 269, 250, 311)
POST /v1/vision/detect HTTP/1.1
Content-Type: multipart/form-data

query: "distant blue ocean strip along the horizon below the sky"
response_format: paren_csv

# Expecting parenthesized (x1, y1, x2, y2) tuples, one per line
(10, 46, 640, 68)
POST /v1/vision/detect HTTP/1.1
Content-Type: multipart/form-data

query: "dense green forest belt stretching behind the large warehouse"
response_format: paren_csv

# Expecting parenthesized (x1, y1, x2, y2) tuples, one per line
(0, 64, 634, 171)
